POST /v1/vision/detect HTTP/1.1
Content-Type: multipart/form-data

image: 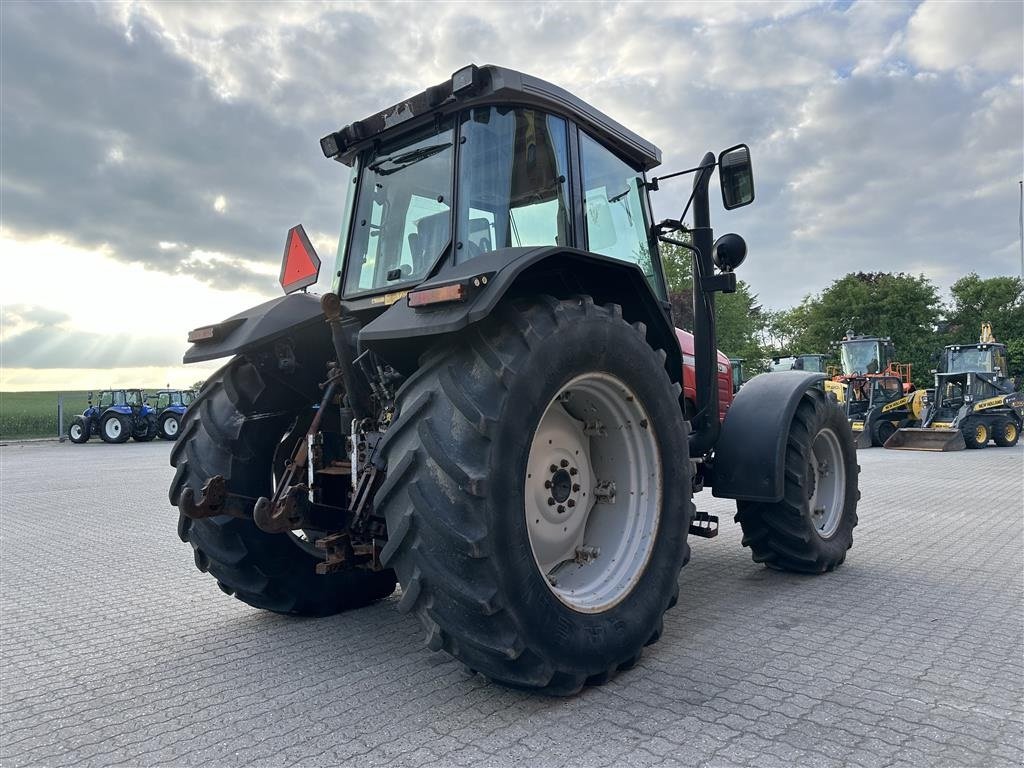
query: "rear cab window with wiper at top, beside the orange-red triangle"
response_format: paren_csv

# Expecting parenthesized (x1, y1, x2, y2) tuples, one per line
(339, 121, 455, 296)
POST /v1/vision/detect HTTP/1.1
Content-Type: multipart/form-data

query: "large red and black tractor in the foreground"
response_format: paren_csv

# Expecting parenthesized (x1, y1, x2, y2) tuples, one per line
(169, 66, 859, 694)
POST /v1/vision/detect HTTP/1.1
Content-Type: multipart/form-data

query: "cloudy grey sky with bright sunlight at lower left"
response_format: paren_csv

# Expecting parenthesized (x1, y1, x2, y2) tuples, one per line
(0, 0, 1024, 390)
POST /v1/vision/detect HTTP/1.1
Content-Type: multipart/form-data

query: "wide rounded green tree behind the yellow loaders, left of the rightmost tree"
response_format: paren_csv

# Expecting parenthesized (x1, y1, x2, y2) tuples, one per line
(776, 272, 942, 386)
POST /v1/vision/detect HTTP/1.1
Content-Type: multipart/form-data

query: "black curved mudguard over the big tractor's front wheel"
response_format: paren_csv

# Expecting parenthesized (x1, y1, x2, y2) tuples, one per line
(712, 371, 834, 503)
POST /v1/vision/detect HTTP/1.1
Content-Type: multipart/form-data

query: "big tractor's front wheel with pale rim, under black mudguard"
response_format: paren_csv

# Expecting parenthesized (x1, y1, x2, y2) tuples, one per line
(736, 389, 860, 573)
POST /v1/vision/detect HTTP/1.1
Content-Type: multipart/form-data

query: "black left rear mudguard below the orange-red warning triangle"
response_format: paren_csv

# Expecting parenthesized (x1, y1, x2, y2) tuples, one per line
(182, 293, 324, 364)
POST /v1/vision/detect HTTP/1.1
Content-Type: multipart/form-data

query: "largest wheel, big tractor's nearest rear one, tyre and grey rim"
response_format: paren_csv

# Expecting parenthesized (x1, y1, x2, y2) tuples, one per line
(375, 296, 693, 695)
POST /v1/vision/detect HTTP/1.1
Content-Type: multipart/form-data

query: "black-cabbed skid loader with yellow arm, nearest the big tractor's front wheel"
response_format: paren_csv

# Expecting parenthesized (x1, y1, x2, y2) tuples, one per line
(842, 376, 925, 449)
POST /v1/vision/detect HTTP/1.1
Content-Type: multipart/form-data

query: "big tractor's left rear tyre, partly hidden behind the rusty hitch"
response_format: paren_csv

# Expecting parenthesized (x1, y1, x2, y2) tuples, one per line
(169, 357, 395, 616)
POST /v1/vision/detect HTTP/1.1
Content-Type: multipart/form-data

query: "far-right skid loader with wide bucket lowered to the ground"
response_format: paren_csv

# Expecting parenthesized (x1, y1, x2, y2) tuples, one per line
(886, 323, 1024, 451)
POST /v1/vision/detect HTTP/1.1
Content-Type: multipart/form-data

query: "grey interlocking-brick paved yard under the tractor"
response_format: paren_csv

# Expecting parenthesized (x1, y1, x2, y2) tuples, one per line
(0, 442, 1024, 767)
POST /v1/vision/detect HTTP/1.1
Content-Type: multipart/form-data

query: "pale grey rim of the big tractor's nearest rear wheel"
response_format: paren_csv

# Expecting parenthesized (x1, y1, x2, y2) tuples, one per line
(524, 373, 662, 613)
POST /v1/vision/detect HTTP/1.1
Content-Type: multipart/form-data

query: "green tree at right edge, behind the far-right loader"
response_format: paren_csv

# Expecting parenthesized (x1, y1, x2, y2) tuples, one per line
(944, 272, 1024, 373)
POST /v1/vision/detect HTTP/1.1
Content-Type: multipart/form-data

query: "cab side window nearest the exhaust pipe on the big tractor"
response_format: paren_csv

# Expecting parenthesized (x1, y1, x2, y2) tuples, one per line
(580, 132, 662, 293)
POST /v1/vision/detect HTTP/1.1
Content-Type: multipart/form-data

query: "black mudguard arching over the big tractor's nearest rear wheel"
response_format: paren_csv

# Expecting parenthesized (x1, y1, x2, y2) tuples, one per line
(359, 246, 682, 382)
